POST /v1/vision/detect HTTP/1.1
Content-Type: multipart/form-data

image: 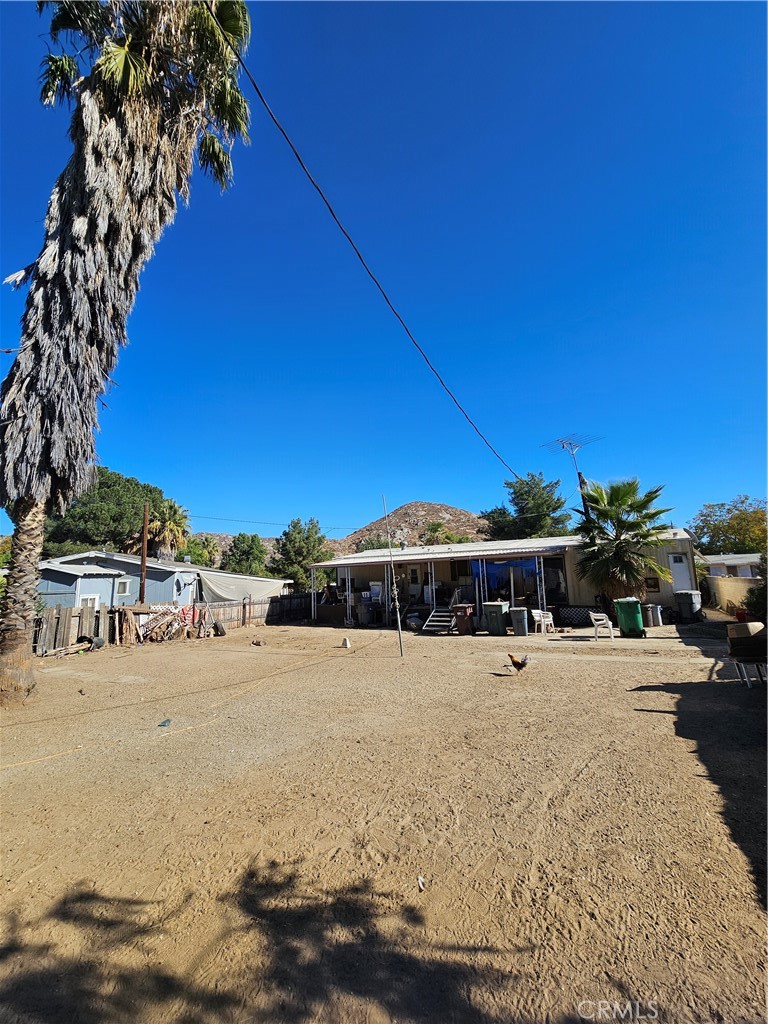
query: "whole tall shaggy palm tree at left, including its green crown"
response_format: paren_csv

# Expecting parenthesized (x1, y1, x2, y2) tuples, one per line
(0, 0, 250, 689)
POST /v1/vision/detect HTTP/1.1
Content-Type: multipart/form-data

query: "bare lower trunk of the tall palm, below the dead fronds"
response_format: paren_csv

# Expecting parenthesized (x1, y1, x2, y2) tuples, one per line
(0, 498, 46, 702)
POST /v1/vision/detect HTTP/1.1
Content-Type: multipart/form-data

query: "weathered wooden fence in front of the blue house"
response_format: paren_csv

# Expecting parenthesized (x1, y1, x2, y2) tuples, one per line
(33, 594, 311, 657)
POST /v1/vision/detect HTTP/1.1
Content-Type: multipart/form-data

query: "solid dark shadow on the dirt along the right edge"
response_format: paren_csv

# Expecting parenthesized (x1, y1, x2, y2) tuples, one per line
(631, 679, 767, 906)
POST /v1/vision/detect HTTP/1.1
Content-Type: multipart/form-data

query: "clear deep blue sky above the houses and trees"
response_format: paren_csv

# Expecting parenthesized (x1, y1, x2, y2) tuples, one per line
(0, 2, 766, 537)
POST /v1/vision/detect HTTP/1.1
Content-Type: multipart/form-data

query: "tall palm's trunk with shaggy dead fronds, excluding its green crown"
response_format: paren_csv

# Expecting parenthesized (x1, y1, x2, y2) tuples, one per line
(0, 87, 195, 699)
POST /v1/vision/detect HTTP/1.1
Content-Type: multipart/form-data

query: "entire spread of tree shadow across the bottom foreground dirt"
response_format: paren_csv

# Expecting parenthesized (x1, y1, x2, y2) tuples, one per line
(0, 862, 614, 1024)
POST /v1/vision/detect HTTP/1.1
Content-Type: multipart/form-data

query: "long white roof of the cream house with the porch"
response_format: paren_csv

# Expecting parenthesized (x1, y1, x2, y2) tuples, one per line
(312, 529, 690, 568)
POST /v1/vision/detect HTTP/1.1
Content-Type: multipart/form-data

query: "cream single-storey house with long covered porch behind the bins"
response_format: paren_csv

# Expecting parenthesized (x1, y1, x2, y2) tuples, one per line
(312, 529, 697, 624)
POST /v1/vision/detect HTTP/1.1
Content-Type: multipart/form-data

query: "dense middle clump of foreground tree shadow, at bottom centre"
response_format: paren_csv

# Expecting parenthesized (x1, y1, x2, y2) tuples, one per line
(228, 862, 519, 1024)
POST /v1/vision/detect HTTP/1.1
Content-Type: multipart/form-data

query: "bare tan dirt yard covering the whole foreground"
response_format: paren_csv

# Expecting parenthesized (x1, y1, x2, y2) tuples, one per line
(0, 627, 766, 1024)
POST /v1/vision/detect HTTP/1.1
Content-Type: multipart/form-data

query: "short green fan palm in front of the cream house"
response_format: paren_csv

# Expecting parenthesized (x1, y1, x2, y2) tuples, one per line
(573, 479, 672, 600)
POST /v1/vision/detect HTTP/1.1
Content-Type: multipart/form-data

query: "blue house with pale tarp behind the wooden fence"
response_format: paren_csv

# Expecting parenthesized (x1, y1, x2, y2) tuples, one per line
(38, 551, 292, 609)
